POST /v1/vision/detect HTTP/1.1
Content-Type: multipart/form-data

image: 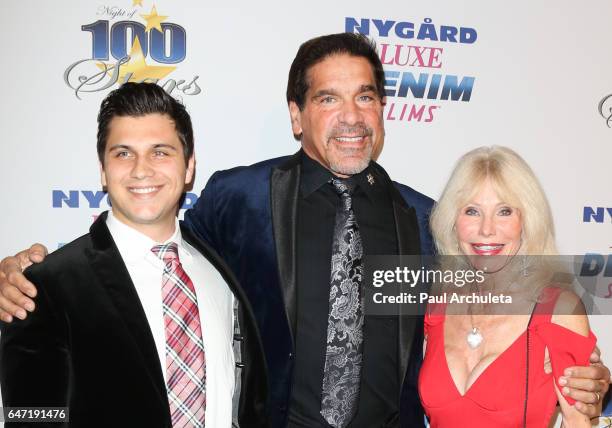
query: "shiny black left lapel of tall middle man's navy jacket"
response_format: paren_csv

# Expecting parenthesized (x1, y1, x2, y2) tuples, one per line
(270, 152, 301, 343)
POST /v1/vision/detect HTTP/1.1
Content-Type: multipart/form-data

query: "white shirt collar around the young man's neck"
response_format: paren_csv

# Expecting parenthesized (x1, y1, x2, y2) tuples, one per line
(106, 211, 193, 265)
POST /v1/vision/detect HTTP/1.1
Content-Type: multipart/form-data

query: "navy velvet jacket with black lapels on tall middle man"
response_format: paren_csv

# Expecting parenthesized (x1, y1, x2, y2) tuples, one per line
(185, 151, 433, 428)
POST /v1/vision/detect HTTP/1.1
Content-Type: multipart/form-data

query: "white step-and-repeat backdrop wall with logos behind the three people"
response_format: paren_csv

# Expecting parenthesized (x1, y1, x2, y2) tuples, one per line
(0, 0, 612, 422)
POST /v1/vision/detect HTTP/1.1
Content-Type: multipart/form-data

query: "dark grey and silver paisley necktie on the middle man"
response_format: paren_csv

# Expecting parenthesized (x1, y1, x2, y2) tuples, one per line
(321, 178, 364, 428)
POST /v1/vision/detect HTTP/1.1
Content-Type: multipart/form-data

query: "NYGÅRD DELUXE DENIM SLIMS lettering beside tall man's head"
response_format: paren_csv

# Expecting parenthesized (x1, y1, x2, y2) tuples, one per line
(344, 16, 478, 123)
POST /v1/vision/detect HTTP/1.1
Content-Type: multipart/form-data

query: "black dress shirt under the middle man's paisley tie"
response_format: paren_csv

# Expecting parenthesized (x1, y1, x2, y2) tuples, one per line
(289, 154, 400, 428)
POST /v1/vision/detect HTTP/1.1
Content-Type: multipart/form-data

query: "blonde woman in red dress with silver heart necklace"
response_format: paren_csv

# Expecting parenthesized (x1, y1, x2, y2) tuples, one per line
(419, 146, 595, 428)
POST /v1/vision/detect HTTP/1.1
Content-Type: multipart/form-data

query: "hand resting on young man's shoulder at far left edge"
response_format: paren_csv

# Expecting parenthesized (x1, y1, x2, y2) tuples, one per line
(0, 244, 47, 322)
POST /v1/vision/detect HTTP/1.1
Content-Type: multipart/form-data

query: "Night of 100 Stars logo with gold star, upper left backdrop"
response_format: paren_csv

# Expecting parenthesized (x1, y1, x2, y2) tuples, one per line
(64, 0, 202, 99)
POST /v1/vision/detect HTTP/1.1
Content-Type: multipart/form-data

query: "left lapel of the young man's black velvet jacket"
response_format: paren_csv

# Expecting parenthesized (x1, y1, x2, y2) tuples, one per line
(87, 212, 169, 410)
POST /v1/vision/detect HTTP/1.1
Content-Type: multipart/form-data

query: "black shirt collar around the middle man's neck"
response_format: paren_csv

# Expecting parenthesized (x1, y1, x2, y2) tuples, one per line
(300, 152, 382, 201)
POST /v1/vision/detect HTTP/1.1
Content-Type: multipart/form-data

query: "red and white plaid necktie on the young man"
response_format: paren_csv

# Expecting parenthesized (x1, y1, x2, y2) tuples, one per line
(151, 242, 206, 428)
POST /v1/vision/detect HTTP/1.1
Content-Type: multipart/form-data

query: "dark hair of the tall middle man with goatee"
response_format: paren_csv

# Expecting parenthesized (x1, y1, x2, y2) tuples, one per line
(287, 33, 385, 110)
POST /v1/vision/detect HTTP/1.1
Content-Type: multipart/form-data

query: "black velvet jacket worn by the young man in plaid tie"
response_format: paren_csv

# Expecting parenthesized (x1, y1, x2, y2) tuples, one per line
(0, 213, 267, 428)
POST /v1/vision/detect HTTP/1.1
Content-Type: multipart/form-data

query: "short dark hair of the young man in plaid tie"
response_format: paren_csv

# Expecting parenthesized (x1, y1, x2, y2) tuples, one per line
(97, 82, 193, 165)
